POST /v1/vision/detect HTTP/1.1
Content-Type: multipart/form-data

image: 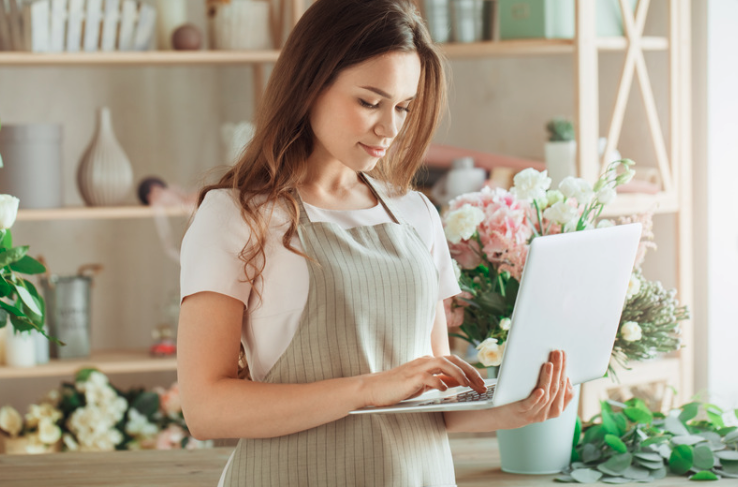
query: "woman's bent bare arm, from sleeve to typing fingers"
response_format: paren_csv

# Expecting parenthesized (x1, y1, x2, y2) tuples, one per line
(177, 292, 486, 439)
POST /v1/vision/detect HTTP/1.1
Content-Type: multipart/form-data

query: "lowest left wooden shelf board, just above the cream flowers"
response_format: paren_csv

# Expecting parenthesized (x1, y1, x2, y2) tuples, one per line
(0, 350, 177, 379)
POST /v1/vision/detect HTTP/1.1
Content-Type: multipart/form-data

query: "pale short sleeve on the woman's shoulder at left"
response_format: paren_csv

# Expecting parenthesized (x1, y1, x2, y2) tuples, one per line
(179, 189, 251, 306)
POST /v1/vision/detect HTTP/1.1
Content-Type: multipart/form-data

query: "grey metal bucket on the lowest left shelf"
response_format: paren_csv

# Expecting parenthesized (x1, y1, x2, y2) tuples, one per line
(41, 264, 102, 359)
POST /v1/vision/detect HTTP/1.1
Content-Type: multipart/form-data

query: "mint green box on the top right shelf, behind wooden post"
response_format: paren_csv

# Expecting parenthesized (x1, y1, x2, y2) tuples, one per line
(498, 0, 637, 39)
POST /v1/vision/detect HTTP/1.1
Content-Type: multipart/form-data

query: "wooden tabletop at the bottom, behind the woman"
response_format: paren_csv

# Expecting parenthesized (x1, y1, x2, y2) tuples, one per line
(0, 435, 688, 487)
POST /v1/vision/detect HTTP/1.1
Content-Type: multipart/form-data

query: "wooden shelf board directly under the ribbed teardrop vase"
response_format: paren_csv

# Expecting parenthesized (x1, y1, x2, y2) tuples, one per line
(17, 206, 193, 221)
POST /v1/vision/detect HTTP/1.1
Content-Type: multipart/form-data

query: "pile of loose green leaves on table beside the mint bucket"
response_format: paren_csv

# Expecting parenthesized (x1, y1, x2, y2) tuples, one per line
(556, 398, 738, 484)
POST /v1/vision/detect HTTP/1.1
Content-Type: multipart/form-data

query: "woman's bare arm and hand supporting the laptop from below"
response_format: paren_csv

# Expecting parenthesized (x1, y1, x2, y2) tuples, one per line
(431, 301, 574, 433)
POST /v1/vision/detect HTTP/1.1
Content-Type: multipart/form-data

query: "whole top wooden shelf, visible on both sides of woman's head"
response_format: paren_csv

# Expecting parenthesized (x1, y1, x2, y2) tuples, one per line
(0, 37, 669, 66)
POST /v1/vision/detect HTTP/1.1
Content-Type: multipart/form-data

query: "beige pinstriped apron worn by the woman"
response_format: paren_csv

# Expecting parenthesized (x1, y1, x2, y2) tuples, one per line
(224, 175, 455, 487)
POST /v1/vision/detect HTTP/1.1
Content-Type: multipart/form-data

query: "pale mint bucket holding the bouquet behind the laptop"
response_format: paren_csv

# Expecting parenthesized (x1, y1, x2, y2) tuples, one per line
(497, 385, 579, 475)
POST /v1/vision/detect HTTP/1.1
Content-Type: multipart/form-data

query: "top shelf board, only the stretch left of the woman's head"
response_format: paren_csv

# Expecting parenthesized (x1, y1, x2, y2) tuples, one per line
(0, 50, 279, 66)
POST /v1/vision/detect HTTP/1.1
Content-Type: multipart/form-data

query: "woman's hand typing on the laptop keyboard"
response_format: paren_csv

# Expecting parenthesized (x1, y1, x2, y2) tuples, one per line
(361, 355, 486, 407)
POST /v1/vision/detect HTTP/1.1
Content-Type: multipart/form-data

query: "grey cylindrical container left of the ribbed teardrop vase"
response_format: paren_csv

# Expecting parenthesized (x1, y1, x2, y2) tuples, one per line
(0, 123, 62, 209)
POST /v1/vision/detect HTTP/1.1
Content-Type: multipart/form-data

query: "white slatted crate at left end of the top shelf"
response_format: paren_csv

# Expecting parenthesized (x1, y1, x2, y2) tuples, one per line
(0, 0, 156, 52)
